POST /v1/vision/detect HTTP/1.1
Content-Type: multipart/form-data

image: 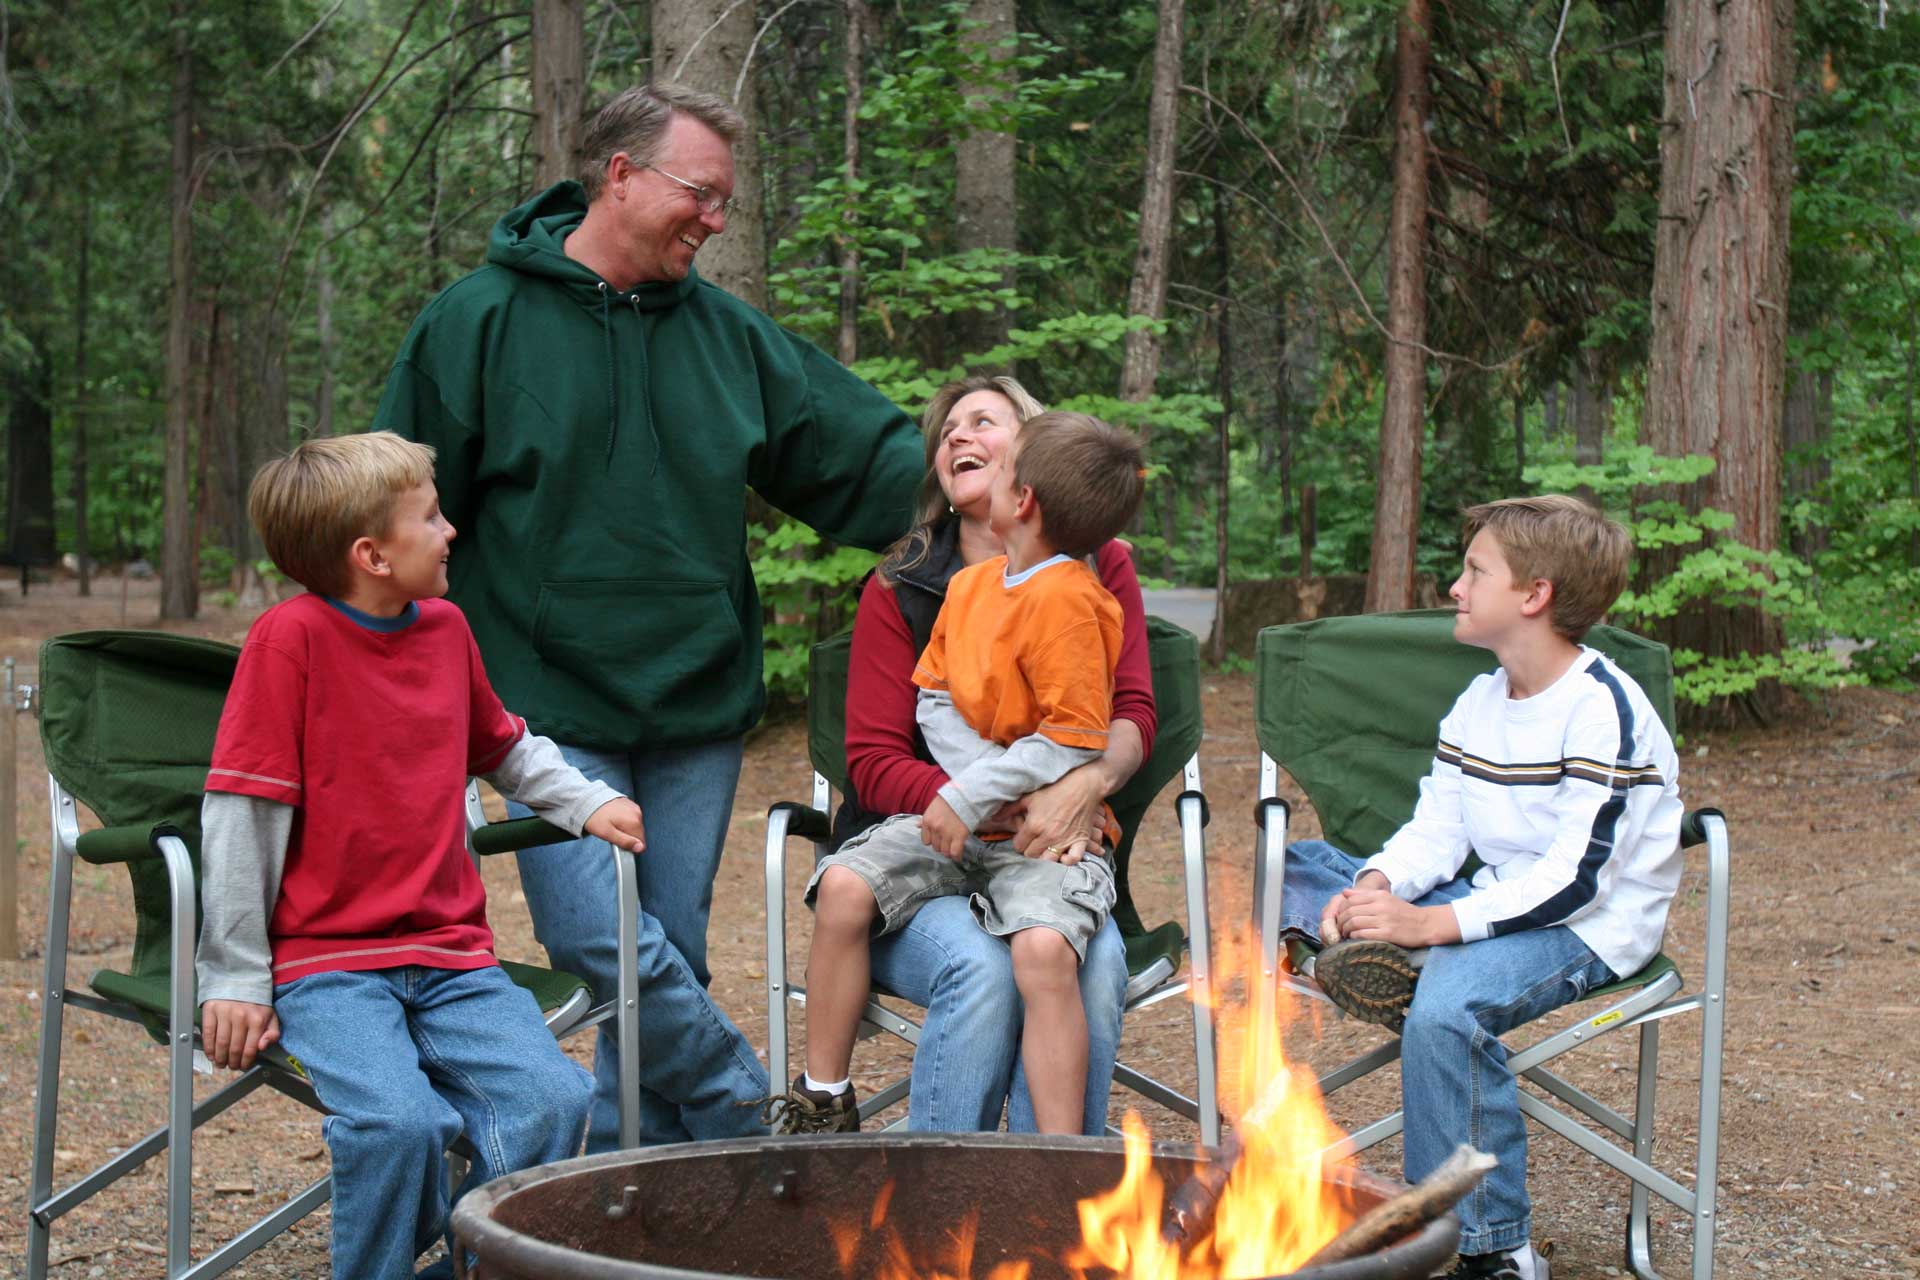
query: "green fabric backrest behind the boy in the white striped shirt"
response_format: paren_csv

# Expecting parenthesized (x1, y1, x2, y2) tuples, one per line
(1254, 608, 1674, 856)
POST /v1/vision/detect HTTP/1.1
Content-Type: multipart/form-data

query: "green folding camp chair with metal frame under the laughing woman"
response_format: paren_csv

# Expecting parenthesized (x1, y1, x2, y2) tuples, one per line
(766, 618, 1219, 1144)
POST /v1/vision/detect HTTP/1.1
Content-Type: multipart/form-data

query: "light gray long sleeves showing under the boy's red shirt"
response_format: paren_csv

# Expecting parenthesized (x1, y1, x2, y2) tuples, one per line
(194, 733, 620, 1004)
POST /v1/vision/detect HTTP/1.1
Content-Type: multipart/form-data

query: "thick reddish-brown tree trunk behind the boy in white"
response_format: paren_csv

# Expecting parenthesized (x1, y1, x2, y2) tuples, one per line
(1644, 0, 1793, 718)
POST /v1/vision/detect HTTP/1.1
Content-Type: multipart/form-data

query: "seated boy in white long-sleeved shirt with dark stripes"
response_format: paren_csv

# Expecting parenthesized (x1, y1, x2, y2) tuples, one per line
(1283, 495, 1682, 1280)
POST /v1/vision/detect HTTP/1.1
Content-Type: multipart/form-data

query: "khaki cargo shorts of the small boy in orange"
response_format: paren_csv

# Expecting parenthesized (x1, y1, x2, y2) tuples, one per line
(806, 814, 1116, 961)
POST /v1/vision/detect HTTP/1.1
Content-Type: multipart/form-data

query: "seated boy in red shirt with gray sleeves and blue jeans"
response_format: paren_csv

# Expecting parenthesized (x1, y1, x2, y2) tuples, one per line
(196, 432, 645, 1280)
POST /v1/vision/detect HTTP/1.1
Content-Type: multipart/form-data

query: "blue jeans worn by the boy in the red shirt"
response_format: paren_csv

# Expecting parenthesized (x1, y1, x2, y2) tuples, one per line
(273, 965, 591, 1280)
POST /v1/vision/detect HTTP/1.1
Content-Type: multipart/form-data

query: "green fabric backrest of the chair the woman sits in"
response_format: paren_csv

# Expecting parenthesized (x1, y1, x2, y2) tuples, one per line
(806, 618, 1200, 936)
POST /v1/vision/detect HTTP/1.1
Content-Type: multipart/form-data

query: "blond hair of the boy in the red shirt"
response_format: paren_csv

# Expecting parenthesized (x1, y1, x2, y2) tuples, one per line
(246, 432, 434, 595)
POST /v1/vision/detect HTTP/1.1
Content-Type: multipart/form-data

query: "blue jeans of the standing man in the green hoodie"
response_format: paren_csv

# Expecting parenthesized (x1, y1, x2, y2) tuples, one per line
(507, 739, 768, 1153)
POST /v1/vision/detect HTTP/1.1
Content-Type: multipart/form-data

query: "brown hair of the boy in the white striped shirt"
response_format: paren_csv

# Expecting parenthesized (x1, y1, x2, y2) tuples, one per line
(1461, 493, 1634, 641)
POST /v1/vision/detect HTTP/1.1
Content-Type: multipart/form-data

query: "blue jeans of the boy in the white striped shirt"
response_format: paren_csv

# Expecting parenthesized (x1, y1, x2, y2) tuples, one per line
(1281, 841, 1615, 1253)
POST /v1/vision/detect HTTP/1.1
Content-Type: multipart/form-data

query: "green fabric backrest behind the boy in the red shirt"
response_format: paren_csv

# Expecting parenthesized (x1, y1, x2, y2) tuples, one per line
(40, 631, 240, 977)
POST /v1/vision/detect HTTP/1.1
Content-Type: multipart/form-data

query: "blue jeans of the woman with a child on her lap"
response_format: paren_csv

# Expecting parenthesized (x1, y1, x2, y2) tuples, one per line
(872, 898, 1127, 1134)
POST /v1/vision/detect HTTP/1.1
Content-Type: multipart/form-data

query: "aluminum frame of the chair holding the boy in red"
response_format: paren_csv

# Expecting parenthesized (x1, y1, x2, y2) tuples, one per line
(27, 775, 639, 1280)
